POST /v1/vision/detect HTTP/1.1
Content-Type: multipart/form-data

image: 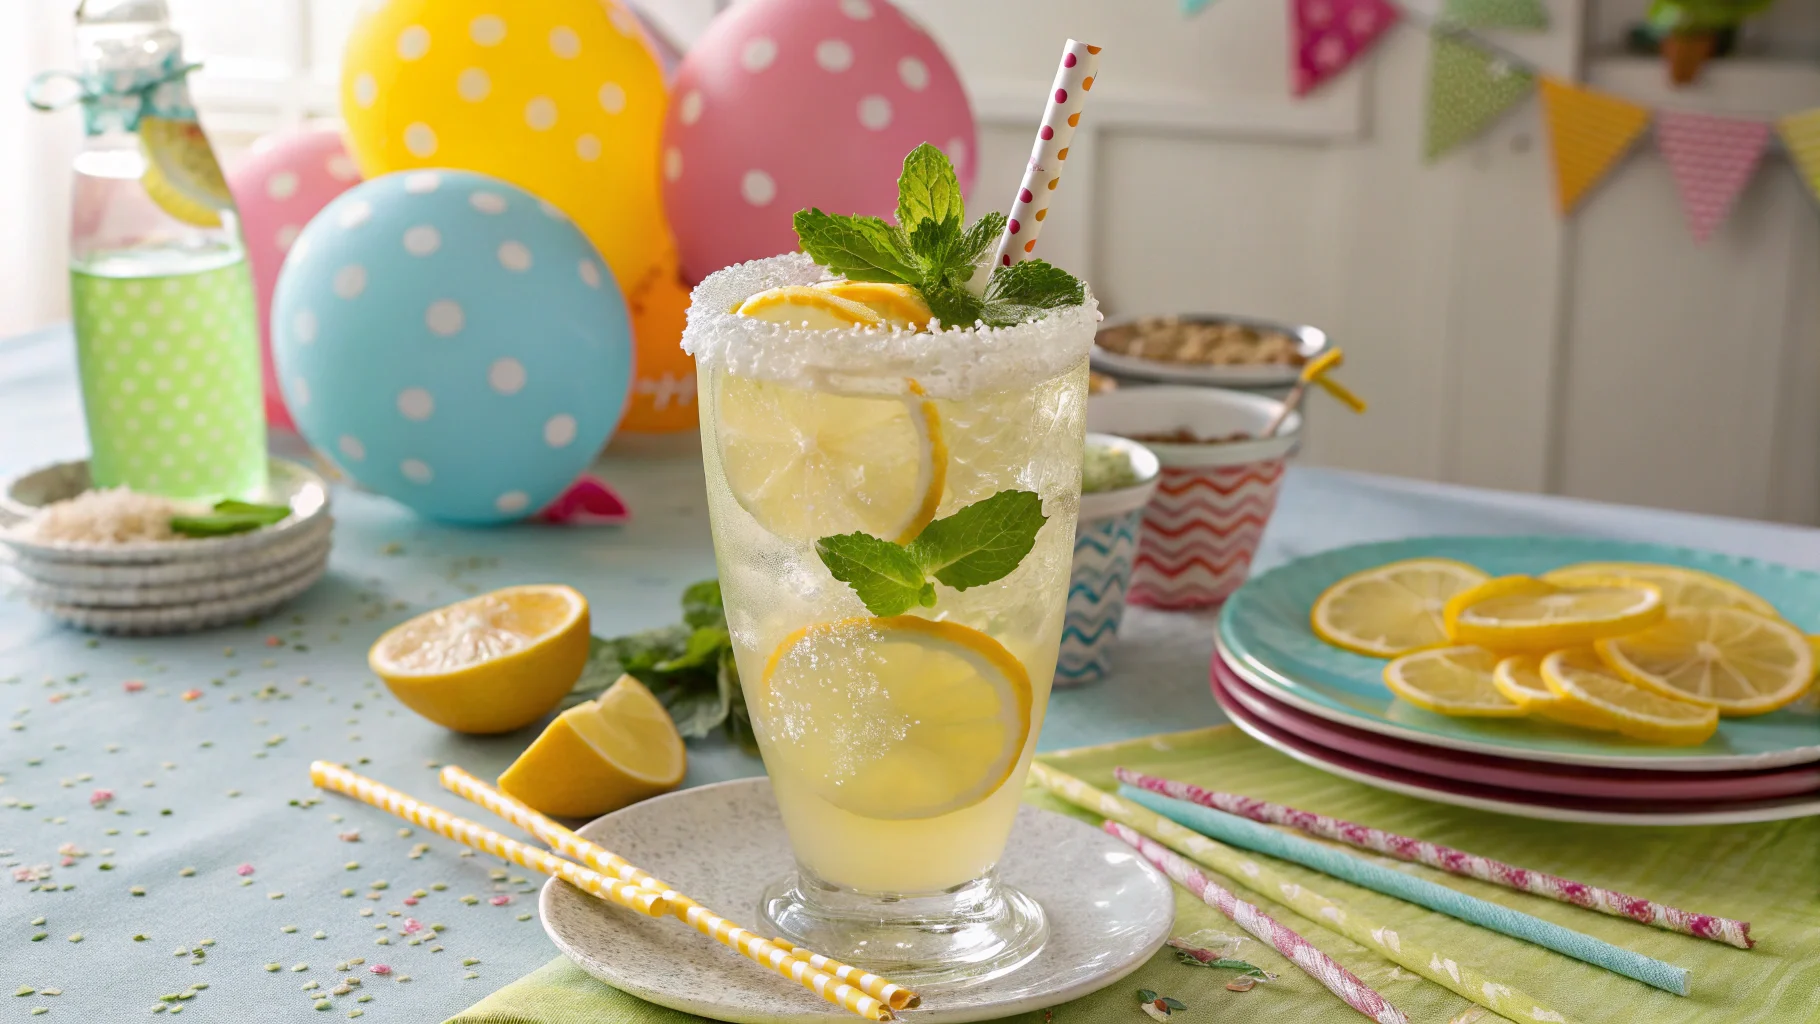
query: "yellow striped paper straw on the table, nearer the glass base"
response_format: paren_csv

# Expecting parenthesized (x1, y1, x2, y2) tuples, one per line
(442, 764, 921, 1020)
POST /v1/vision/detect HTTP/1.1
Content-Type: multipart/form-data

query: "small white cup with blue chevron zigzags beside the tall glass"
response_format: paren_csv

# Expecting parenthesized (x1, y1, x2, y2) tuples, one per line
(1056, 435, 1159, 686)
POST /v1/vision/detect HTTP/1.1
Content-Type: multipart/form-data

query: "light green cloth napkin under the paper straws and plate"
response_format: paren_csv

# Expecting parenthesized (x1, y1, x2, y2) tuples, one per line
(450, 726, 1820, 1024)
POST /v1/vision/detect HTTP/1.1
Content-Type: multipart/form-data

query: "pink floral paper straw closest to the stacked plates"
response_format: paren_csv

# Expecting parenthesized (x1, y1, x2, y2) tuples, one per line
(1117, 768, 1754, 949)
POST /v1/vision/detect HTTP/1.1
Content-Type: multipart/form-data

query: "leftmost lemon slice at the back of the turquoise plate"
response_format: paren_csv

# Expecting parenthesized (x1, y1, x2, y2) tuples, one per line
(1309, 558, 1487, 658)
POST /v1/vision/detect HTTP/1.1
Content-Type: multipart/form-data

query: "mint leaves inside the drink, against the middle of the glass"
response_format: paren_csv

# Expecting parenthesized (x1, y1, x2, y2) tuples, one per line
(815, 491, 1048, 617)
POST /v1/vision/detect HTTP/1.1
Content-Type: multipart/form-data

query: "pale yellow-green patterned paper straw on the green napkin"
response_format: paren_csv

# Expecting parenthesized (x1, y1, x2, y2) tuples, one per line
(1030, 762, 1571, 1024)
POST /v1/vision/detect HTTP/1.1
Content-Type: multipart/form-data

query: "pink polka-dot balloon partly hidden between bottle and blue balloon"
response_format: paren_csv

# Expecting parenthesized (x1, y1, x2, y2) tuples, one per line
(228, 124, 360, 431)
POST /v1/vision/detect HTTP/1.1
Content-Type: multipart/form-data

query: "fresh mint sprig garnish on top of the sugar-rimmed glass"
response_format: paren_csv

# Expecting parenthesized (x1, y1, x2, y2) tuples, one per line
(795, 142, 1087, 327)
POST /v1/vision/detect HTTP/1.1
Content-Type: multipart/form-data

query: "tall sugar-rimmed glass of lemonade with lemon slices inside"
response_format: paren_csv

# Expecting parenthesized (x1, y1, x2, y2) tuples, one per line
(684, 255, 1097, 989)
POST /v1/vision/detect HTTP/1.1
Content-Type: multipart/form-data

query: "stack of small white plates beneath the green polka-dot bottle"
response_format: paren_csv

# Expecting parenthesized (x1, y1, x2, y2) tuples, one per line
(0, 458, 335, 635)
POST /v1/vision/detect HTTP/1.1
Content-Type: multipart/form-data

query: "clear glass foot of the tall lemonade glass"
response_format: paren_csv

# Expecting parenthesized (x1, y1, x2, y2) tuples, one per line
(759, 866, 1048, 993)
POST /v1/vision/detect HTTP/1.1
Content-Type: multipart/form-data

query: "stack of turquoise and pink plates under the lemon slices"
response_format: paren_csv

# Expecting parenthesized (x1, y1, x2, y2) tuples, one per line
(1212, 537, 1820, 824)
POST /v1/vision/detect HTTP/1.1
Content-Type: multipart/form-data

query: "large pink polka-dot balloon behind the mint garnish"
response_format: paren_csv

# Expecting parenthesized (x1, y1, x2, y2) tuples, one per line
(662, 0, 977, 282)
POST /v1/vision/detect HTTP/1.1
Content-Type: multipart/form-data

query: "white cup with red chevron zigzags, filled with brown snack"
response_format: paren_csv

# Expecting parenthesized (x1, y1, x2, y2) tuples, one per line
(1087, 387, 1301, 609)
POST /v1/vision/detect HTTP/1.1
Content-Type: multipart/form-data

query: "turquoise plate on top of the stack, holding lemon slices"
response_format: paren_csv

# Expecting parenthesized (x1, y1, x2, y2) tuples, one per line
(1219, 537, 1820, 771)
